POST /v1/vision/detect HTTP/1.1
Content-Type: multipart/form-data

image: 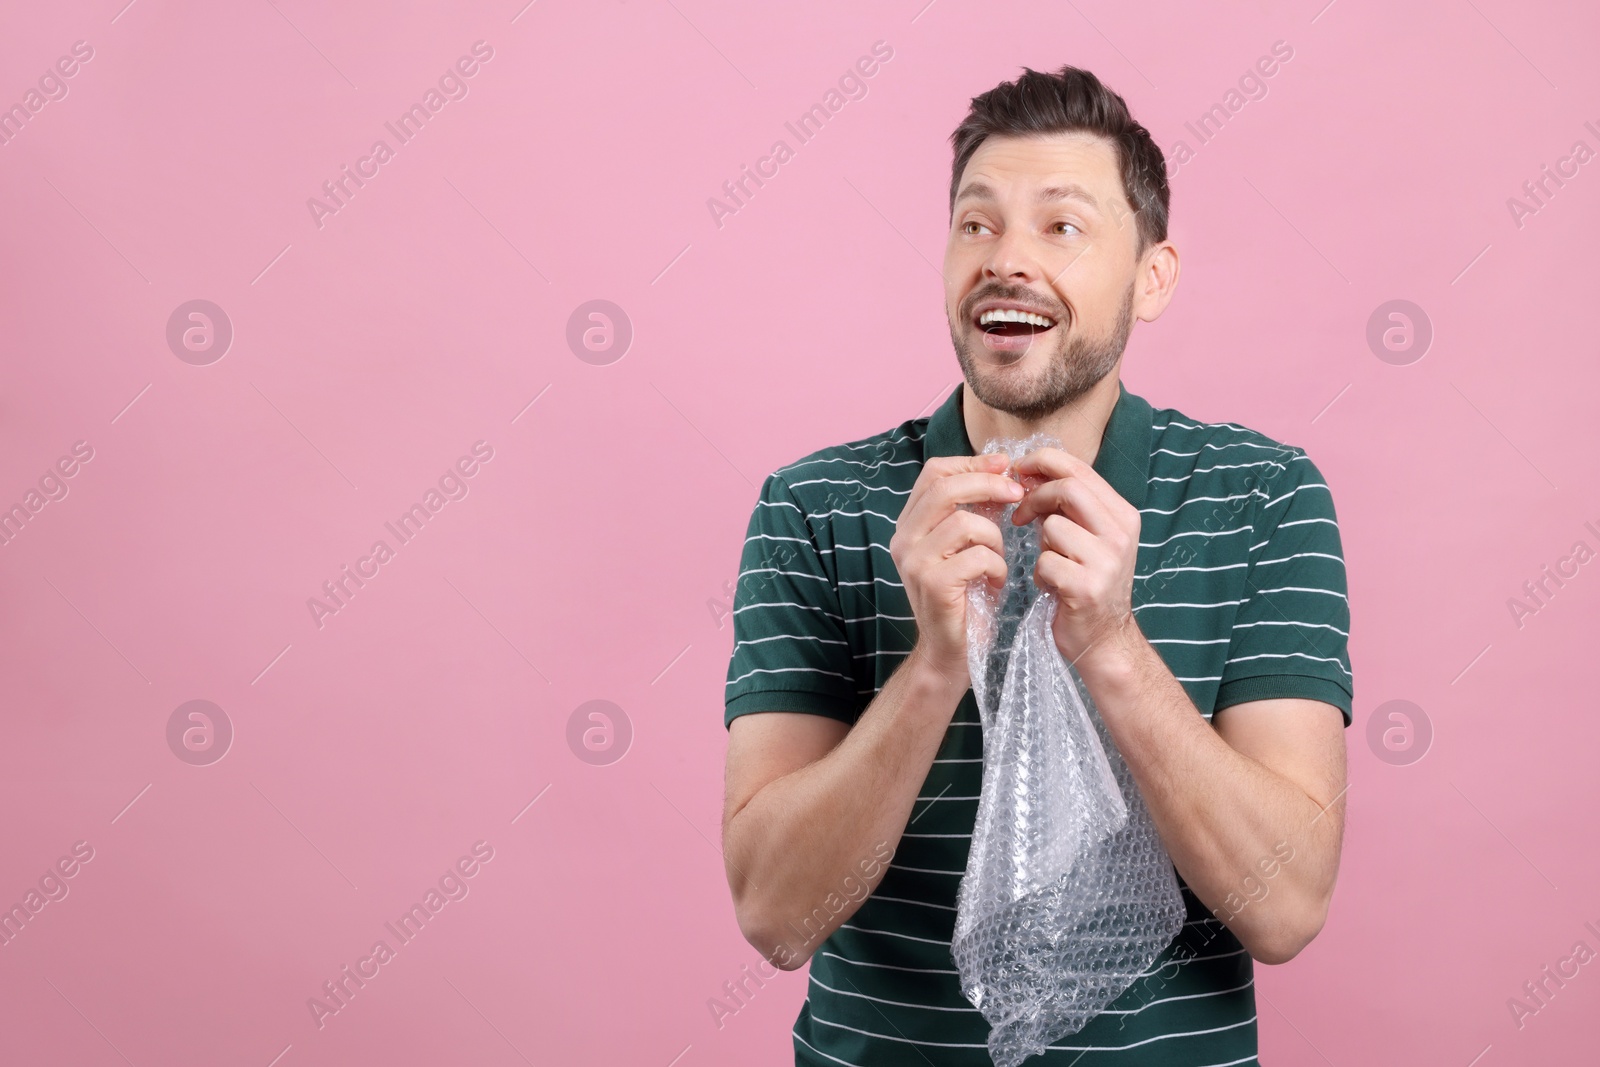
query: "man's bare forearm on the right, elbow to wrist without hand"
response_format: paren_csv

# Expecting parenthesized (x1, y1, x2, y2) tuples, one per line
(1080, 635, 1342, 963)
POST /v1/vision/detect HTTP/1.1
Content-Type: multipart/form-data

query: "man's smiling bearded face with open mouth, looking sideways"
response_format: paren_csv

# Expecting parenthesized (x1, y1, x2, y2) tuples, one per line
(944, 133, 1142, 419)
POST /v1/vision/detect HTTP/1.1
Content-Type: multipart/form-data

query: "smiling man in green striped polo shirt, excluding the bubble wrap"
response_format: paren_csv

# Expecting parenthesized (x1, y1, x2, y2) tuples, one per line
(723, 67, 1352, 1067)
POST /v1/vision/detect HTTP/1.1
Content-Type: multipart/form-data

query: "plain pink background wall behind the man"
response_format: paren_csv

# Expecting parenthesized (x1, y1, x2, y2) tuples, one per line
(0, 0, 1600, 1067)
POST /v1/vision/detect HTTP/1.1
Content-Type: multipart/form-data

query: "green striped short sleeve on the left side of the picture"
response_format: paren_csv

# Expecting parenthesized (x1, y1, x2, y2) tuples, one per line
(723, 474, 858, 725)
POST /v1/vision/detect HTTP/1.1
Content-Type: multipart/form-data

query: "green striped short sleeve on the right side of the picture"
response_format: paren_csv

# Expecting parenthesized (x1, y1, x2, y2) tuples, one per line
(1214, 448, 1354, 726)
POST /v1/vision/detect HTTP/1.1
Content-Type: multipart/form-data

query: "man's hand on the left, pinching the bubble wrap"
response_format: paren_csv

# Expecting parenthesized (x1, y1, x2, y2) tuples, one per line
(890, 453, 1022, 685)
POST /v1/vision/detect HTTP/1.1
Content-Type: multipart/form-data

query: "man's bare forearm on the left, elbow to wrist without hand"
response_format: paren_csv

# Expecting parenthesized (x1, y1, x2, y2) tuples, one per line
(723, 653, 966, 969)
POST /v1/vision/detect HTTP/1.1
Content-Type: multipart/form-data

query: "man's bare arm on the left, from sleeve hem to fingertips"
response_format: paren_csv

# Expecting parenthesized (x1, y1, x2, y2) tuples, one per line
(722, 454, 1022, 969)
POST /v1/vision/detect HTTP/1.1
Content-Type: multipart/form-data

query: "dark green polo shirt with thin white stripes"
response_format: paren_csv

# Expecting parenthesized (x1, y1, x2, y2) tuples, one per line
(725, 379, 1350, 1067)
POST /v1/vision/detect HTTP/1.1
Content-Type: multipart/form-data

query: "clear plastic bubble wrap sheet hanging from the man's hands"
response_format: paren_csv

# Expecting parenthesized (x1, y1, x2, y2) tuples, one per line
(950, 435, 1184, 1067)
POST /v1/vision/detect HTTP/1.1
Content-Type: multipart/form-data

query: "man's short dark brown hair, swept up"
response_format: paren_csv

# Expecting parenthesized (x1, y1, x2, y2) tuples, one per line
(950, 67, 1171, 254)
